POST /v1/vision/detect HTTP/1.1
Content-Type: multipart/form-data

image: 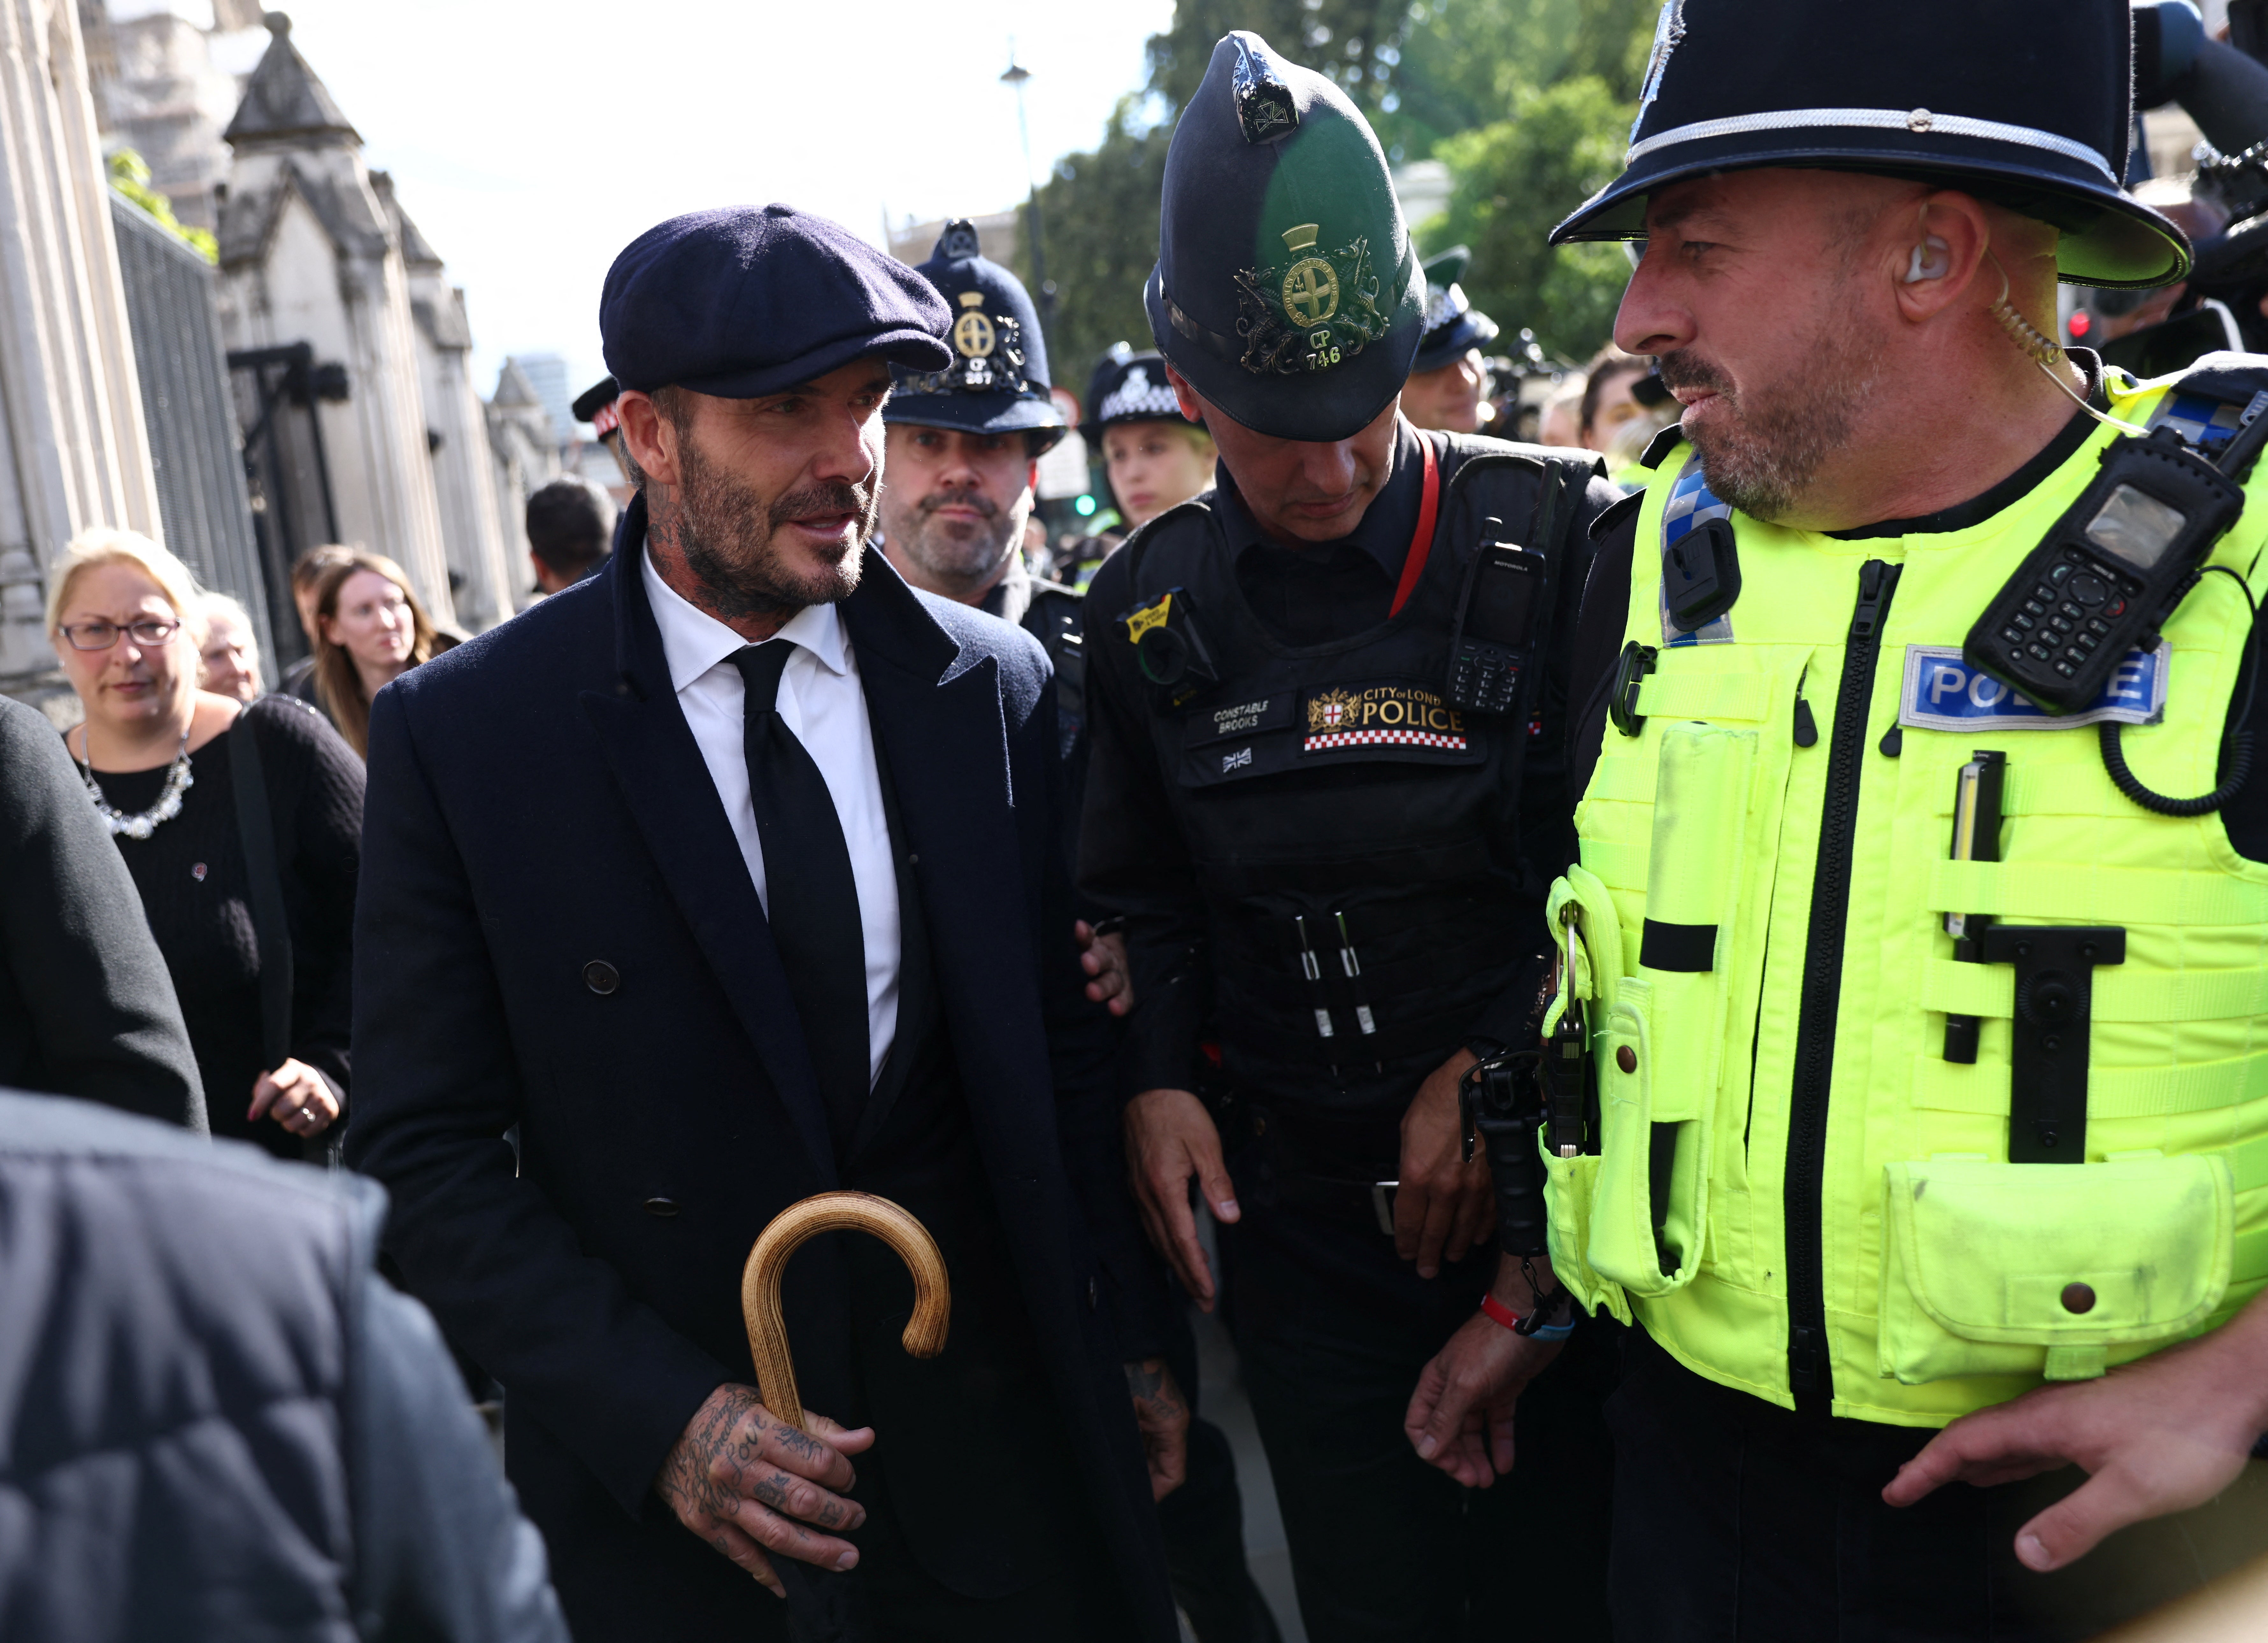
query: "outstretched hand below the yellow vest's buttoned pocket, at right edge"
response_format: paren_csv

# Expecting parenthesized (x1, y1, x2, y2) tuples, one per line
(1882, 1300, 2268, 1573)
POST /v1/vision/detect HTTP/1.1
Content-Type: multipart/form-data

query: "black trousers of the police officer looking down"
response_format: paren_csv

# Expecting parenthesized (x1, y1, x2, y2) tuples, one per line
(1220, 1194, 1622, 1643)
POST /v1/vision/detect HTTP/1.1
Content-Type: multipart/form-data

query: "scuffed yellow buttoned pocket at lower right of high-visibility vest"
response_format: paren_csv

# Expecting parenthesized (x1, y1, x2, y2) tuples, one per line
(1878, 1153, 2236, 1387)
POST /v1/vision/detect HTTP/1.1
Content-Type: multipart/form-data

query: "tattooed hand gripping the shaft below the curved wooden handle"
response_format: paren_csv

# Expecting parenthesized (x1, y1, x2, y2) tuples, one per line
(653, 1382, 875, 1598)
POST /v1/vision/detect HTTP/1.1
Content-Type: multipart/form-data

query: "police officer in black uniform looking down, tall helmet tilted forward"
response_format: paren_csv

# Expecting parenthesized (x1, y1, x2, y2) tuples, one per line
(1080, 34, 1617, 1643)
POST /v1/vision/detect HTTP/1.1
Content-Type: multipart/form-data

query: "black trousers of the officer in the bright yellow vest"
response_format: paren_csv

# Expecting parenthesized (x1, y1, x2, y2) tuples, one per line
(1608, 1330, 2268, 1643)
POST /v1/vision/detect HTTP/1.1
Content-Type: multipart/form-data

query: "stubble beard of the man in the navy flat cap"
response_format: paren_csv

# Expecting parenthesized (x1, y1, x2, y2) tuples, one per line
(671, 438, 878, 622)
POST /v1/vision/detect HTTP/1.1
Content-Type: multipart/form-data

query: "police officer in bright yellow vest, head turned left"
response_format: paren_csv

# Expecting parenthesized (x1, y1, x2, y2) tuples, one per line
(1411, 0, 2268, 1643)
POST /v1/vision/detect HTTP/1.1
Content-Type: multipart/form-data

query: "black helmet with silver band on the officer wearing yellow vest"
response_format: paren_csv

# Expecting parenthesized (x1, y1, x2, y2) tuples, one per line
(1551, 0, 2189, 288)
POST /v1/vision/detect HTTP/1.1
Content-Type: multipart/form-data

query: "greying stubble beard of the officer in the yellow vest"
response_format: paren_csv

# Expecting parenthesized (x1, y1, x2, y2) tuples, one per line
(1660, 272, 1882, 522)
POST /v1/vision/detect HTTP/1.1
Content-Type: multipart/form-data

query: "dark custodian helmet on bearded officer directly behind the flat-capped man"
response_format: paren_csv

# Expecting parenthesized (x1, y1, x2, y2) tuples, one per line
(882, 218, 1068, 454)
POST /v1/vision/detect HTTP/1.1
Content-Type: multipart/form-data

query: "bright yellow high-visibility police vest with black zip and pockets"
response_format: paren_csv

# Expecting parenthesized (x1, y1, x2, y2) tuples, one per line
(1547, 381, 2268, 1425)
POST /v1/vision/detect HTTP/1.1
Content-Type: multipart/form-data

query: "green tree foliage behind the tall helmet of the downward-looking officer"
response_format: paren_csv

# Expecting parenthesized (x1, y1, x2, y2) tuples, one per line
(1016, 0, 1660, 393)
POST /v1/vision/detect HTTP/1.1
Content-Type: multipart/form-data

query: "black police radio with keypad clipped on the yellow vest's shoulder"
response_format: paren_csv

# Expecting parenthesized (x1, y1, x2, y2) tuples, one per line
(1962, 404, 2268, 715)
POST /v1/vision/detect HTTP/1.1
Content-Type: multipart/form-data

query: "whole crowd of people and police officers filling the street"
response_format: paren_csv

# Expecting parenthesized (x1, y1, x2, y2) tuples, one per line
(13, 0, 2268, 1643)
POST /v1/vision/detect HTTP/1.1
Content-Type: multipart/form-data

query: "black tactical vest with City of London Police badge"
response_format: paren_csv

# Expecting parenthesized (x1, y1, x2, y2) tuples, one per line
(1089, 436, 1592, 1096)
